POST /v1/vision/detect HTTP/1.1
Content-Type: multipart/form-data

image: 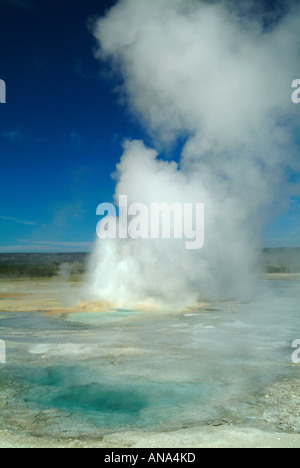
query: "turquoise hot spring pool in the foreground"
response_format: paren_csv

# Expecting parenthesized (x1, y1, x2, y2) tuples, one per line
(18, 366, 217, 428)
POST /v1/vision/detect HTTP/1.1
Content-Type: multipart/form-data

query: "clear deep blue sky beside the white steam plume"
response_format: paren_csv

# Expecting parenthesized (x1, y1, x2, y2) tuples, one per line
(0, 0, 300, 252)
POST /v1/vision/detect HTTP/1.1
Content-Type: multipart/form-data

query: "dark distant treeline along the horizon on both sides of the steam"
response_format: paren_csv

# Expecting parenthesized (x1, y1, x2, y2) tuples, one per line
(0, 248, 300, 278)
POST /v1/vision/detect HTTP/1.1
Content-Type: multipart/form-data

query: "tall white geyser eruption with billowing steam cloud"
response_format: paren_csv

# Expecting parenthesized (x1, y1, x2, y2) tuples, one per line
(84, 0, 300, 307)
